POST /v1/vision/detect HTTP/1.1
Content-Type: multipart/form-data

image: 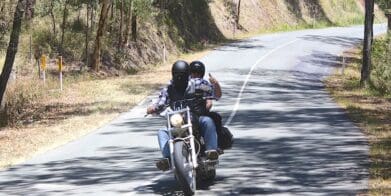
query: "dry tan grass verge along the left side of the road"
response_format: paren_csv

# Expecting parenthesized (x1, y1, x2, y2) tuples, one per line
(0, 48, 208, 168)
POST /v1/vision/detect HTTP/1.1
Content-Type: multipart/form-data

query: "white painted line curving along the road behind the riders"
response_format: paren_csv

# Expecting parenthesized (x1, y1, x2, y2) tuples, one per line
(224, 39, 299, 126)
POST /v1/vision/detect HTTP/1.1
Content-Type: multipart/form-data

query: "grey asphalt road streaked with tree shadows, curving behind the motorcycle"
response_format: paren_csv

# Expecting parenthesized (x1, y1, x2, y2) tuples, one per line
(0, 25, 386, 195)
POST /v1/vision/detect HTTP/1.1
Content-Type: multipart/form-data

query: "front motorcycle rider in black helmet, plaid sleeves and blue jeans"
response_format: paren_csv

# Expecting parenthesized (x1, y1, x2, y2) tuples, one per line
(147, 60, 219, 171)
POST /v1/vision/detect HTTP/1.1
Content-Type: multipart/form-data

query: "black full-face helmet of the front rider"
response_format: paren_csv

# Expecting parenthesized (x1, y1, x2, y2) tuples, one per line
(171, 60, 190, 90)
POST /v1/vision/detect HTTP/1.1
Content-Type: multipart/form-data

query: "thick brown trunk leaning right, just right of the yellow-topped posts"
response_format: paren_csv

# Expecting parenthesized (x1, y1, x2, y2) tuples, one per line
(91, 0, 111, 71)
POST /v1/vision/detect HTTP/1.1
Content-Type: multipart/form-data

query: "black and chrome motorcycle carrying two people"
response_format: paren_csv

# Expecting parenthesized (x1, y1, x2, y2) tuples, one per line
(155, 99, 218, 195)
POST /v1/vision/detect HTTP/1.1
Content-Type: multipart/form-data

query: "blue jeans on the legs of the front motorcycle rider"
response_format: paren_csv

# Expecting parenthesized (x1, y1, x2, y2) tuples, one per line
(158, 116, 217, 158)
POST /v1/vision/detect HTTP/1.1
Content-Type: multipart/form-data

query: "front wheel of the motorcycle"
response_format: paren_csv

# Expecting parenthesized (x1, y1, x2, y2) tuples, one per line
(174, 141, 196, 195)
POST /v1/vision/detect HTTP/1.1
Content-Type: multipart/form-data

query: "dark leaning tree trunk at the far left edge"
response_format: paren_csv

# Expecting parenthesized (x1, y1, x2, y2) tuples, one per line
(0, 0, 26, 104)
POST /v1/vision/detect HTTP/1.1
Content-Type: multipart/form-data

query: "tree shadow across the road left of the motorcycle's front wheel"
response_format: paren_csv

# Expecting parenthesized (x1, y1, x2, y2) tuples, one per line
(0, 146, 167, 195)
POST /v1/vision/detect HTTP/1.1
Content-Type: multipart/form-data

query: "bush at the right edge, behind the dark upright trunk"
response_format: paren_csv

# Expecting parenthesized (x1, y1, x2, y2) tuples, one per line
(371, 37, 391, 95)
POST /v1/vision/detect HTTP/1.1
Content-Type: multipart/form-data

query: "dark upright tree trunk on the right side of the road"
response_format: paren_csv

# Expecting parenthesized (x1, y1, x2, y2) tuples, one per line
(360, 0, 375, 86)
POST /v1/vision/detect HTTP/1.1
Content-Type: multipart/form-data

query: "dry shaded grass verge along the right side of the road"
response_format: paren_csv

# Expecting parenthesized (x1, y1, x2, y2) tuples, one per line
(326, 46, 391, 195)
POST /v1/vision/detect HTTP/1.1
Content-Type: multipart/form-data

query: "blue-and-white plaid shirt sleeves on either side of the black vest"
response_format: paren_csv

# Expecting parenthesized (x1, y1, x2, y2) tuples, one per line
(153, 78, 214, 111)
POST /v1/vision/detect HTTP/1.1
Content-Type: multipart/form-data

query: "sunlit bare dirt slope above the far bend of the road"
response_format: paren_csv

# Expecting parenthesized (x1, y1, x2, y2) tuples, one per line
(209, 0, 384, 38)
